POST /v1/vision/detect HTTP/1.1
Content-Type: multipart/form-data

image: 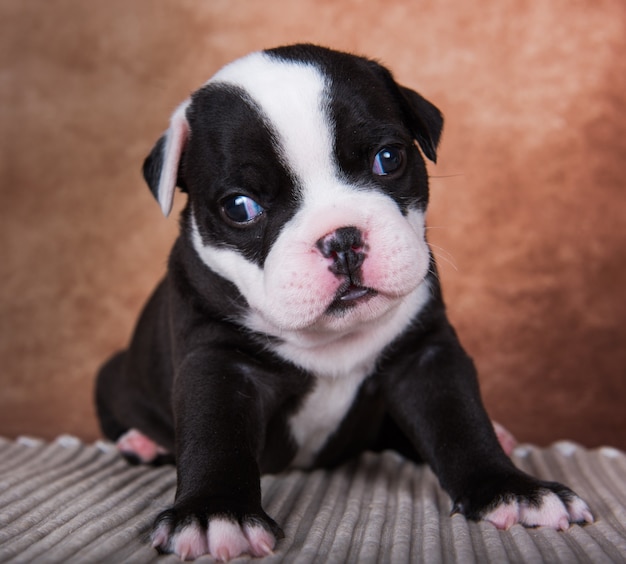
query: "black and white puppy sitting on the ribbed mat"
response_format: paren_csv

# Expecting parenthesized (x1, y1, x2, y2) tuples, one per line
(97, 45, 593, 560)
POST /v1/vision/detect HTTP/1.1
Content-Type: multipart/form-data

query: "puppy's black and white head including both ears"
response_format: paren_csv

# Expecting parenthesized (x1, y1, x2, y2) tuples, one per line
(144, 45, 443, 334)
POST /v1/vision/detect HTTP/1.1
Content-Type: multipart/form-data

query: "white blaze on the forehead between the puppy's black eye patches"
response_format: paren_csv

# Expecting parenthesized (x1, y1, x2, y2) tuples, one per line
(208, 53, 336, 187)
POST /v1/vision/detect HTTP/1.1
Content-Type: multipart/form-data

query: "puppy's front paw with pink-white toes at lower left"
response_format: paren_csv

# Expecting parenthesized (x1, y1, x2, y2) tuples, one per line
(151, 509, 283, 562)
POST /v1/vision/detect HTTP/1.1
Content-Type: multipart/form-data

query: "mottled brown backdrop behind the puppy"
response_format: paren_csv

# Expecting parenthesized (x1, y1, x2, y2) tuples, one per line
(0, 0, 626, 448)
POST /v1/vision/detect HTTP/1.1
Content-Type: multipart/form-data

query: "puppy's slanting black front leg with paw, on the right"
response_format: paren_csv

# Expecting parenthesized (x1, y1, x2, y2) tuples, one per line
(385, 313, 593, 529)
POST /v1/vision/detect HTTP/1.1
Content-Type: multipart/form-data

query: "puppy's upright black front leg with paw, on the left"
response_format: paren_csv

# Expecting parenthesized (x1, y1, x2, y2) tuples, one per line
(152, 351, 282, 561)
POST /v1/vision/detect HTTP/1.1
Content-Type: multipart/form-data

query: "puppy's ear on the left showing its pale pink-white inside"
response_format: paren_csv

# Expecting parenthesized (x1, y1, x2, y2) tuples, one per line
(143, 100, 190, 217)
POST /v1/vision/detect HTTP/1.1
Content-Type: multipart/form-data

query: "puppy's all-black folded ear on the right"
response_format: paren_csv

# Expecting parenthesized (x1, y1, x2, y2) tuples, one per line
(398, 86, 443, 163)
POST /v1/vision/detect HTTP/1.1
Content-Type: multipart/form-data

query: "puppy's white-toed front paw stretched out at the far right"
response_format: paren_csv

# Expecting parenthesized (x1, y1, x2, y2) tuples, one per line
(453, 474, 593, 530)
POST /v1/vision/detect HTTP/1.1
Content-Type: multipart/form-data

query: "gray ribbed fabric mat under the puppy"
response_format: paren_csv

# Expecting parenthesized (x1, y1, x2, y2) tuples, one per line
(0, 437, 626, 564)
